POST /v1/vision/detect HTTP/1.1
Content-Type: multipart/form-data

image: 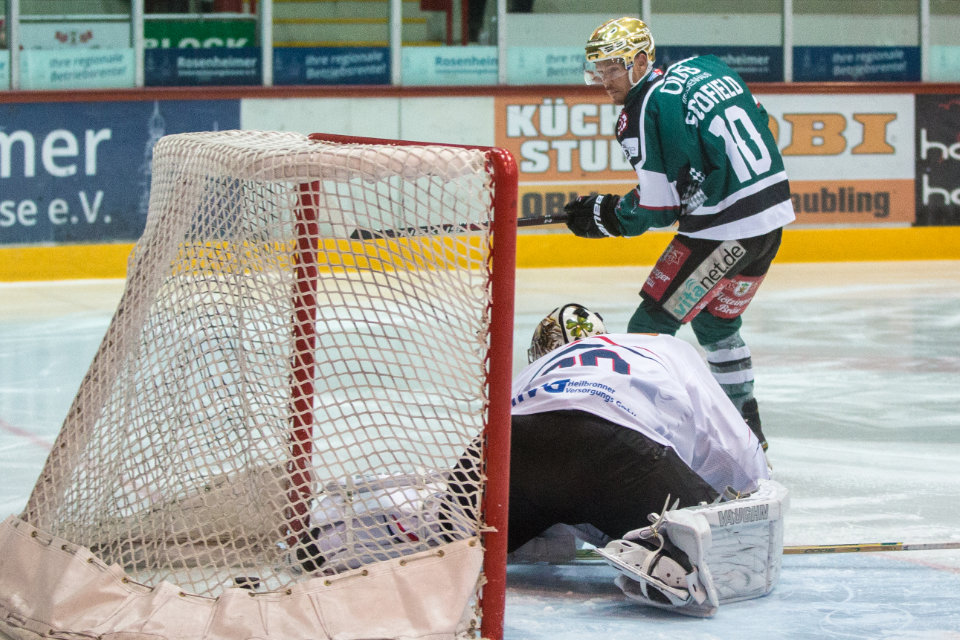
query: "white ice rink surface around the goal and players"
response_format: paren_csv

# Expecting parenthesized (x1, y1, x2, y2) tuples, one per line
(0, 262, 960, 640)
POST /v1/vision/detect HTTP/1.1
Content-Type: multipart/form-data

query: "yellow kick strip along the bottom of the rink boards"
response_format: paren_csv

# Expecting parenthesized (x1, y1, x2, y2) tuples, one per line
(0, 227, 960, 282)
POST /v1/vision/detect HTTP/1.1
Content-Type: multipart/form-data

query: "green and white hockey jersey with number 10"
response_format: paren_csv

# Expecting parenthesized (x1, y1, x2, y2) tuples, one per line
(617, 55, 795, 240)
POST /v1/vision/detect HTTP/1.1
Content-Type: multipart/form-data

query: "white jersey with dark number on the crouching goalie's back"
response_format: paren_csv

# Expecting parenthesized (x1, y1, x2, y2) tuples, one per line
(512, 333, 769, 492)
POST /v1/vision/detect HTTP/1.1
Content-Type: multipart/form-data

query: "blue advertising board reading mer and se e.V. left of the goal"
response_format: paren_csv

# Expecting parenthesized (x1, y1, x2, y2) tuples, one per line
(0, 100, 240, 246)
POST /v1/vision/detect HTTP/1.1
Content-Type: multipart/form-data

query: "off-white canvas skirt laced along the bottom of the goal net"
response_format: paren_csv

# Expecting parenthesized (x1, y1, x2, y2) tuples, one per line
(0, 516, 483, 640)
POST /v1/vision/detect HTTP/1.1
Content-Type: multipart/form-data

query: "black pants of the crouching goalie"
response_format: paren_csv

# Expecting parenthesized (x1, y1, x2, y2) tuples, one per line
(454, 411, 717, 551)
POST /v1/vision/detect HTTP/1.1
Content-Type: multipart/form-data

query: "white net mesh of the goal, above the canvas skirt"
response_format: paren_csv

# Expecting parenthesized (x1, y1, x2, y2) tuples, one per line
(23, 131, 502, 596)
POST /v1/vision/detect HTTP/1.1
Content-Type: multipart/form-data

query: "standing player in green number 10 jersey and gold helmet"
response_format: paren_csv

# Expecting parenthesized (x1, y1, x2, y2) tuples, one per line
(565, 18, 795, 449)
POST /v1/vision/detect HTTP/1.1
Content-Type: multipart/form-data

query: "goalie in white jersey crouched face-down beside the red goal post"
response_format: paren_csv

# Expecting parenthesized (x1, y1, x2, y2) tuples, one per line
(298, 304, 786, 616)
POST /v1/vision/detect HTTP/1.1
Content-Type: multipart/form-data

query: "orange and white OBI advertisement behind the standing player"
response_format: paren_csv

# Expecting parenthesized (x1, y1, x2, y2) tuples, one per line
(496, 90, 920, 226)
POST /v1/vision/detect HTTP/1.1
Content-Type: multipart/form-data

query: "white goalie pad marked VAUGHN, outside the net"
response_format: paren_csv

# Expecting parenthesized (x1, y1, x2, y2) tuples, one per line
(598, 480, 789, 617)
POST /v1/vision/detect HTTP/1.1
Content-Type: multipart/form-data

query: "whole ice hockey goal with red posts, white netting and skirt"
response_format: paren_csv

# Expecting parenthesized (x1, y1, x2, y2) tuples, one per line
(0, 131, 516, 640)
